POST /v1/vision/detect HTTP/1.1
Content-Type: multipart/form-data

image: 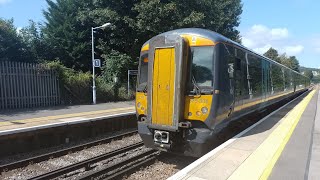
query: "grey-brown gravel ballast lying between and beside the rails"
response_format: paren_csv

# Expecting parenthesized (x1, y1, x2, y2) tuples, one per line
(0, 131, 196, 180)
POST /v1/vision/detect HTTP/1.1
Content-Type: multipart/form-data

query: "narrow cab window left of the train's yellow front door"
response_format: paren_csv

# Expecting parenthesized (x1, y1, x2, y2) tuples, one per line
(137, 53, 148, 91)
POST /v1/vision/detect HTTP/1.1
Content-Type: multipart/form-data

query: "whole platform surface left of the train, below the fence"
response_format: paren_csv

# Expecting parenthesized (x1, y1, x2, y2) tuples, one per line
(0, 101, 135, 136)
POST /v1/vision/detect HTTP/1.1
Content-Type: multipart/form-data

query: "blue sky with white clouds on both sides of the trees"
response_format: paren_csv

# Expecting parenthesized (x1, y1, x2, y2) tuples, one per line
(0, 0, 320, 68)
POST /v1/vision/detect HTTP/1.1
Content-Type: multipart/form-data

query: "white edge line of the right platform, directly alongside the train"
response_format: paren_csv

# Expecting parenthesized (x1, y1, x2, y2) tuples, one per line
(167, 91, 308, 180)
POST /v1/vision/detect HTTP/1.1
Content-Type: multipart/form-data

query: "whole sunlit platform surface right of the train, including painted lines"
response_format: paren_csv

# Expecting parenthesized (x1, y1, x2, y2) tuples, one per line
(168, 88, 320, 180)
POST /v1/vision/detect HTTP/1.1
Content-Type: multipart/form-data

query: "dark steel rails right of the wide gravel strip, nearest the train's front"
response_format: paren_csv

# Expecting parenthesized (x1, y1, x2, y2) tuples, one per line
(29, 142, 157, 180)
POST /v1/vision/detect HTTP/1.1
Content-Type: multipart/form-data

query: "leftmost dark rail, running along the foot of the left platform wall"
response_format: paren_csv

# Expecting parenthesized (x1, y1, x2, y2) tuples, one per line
(0, 130, 138, 172)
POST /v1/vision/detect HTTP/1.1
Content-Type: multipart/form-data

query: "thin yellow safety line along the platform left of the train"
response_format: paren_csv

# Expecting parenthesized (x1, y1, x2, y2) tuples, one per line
(0, 107, 135, 126)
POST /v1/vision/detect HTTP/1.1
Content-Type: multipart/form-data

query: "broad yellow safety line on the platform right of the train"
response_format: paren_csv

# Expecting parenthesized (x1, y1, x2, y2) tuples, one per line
(228, 90, 315, 180)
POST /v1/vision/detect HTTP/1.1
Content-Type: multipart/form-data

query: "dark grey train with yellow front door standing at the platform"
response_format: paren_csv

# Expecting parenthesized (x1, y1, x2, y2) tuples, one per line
(135, 28, 310, 157)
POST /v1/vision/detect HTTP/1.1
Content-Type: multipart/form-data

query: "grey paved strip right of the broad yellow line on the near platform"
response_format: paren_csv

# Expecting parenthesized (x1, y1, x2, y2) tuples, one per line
(269, 89, 319, 180)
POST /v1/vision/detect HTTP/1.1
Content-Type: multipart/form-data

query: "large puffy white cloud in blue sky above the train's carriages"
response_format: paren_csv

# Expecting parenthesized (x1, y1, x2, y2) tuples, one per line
(241, 24, 304, 56)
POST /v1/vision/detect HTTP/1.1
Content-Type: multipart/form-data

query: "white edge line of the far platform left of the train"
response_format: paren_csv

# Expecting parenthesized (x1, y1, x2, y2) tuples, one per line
(0, 111, 135, 136)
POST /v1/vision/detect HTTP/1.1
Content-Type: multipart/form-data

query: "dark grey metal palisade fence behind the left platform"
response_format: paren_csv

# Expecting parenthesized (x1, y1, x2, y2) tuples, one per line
(0, 62, 60, 110)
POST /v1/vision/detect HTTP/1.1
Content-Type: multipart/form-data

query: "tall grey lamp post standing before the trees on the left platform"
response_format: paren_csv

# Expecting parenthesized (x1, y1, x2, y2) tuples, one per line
(91, 23, 111, 104)
